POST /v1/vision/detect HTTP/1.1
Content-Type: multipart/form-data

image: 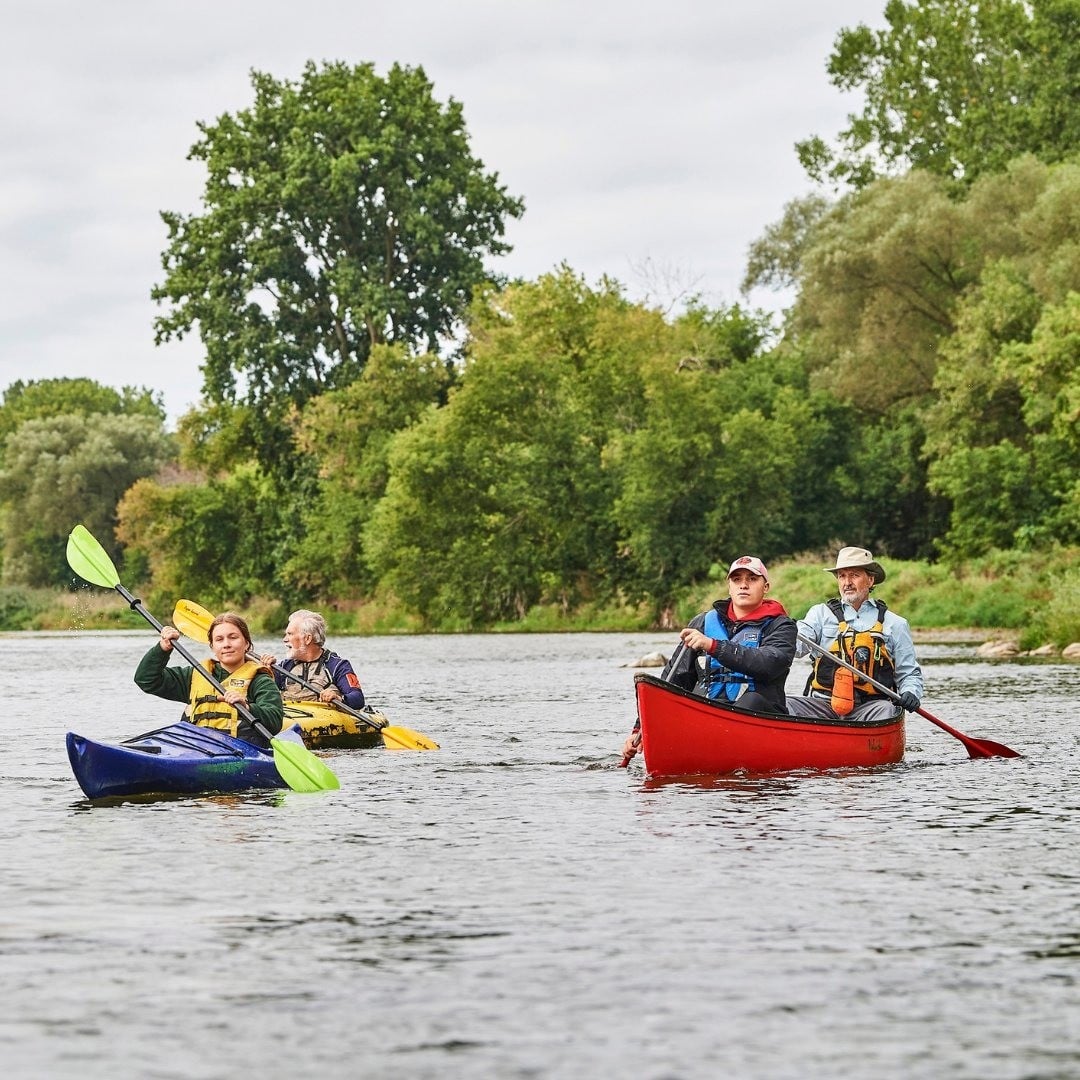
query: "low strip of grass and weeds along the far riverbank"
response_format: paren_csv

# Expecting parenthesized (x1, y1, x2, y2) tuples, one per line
(10, 548, 1080, 654)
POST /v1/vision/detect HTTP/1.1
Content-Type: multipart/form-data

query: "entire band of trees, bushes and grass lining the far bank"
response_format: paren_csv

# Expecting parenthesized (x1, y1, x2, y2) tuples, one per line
(0, 0, 1080, 647)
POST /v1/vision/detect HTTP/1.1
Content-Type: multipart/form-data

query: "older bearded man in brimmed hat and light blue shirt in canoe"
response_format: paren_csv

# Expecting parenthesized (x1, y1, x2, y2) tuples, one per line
(787, 548, 922, 720)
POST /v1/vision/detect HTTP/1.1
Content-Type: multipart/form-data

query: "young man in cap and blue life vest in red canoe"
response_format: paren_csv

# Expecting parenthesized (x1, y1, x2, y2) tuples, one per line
(623, 555, 796, 759)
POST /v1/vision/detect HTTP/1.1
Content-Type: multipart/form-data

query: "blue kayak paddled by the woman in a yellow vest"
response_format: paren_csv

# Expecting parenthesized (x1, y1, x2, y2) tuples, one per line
(67, 723, 298, 799)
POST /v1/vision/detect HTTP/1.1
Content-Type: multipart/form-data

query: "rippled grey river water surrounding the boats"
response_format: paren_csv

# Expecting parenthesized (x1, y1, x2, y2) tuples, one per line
(0, 631, 1080, 1080)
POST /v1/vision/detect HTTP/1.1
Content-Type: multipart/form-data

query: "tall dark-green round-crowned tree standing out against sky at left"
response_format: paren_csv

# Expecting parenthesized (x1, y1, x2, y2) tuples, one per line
(152, 63, 523, 475)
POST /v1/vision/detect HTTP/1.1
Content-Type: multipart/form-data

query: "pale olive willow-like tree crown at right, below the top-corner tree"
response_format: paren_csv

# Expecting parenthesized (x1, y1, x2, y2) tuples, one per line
(759, 156, 1077, 416)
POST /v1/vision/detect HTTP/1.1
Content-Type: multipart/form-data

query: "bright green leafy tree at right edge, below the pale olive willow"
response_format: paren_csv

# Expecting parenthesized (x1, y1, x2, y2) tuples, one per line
(929, 278, 1080, 556)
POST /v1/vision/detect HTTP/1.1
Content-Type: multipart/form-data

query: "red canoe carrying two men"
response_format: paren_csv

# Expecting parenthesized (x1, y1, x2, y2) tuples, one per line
(634, 674, 904, 777)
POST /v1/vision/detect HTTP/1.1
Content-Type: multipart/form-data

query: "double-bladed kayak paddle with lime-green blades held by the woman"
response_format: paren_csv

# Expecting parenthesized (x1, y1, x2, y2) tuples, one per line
(67, 525, 340, 792)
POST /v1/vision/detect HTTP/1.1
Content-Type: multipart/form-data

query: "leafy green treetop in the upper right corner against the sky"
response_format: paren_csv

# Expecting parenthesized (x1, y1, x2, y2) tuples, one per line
(796, 0, 1080, 188)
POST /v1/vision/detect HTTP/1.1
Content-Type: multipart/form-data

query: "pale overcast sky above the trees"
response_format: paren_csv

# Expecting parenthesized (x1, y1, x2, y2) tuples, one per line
(0, 0, 883, 419)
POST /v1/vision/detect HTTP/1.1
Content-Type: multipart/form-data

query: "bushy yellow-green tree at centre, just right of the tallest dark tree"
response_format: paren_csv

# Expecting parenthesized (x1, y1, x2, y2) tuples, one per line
(364, 267, 664, 625)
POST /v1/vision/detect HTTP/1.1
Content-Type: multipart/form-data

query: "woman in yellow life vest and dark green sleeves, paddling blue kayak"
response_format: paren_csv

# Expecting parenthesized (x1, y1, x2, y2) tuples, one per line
(135, 611, 285, 746)
